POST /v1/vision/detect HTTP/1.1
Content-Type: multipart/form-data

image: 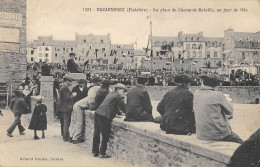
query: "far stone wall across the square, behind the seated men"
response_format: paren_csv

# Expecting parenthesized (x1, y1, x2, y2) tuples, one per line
(146, 86, 260, 104)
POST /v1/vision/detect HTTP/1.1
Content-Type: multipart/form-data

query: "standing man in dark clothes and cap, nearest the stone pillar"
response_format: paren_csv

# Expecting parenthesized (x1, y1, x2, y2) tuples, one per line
(58, 77, 76, 142)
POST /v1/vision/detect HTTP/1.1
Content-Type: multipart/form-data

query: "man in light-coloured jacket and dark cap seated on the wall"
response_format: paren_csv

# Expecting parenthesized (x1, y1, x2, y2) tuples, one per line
(193, 75, 243, 143)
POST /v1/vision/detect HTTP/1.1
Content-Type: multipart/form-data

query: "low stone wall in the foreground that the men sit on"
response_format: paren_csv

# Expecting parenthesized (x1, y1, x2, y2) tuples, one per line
(85, 110, 239, 167)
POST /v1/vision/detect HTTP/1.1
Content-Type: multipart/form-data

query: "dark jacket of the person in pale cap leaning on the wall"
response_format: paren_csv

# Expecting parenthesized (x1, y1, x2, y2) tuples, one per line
(96, 91, 125, 121)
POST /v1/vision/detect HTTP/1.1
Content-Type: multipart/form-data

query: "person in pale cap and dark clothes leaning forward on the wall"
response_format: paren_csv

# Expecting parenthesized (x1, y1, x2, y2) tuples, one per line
(92, 83, 127, 158)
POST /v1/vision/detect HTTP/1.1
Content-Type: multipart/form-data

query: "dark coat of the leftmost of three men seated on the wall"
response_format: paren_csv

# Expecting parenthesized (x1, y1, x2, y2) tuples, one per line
(125, 85, 154, 121)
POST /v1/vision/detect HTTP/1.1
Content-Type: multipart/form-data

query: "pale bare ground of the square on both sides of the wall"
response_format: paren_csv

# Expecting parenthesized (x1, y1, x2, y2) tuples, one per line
(0, 101, 260, 167)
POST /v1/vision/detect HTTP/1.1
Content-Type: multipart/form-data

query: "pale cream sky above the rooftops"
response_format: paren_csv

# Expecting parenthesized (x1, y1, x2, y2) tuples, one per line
(27, 0, 260, 49)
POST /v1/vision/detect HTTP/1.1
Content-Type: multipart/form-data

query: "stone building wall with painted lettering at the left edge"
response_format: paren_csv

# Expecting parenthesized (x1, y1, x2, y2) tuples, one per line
(0, 0, 27, 82)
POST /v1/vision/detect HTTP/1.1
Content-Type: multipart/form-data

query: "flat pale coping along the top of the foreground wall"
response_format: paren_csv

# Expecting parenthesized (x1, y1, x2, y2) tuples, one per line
(85, 110, 240, 164)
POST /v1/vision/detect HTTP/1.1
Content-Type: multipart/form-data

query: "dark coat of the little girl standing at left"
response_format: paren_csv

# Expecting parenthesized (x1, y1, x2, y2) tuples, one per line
(28, 104, 47, 130)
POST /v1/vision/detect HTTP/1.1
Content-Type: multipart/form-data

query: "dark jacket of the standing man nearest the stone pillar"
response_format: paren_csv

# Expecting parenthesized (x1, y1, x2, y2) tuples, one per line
(58, 85, 74, 112)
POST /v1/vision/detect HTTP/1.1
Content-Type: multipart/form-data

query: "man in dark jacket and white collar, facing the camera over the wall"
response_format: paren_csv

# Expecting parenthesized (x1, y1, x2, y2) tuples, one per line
(72, 79, 88, 103)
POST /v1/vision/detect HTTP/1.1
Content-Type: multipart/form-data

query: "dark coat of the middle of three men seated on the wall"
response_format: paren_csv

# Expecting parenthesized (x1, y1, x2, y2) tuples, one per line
(157, 86, 195, 135)
